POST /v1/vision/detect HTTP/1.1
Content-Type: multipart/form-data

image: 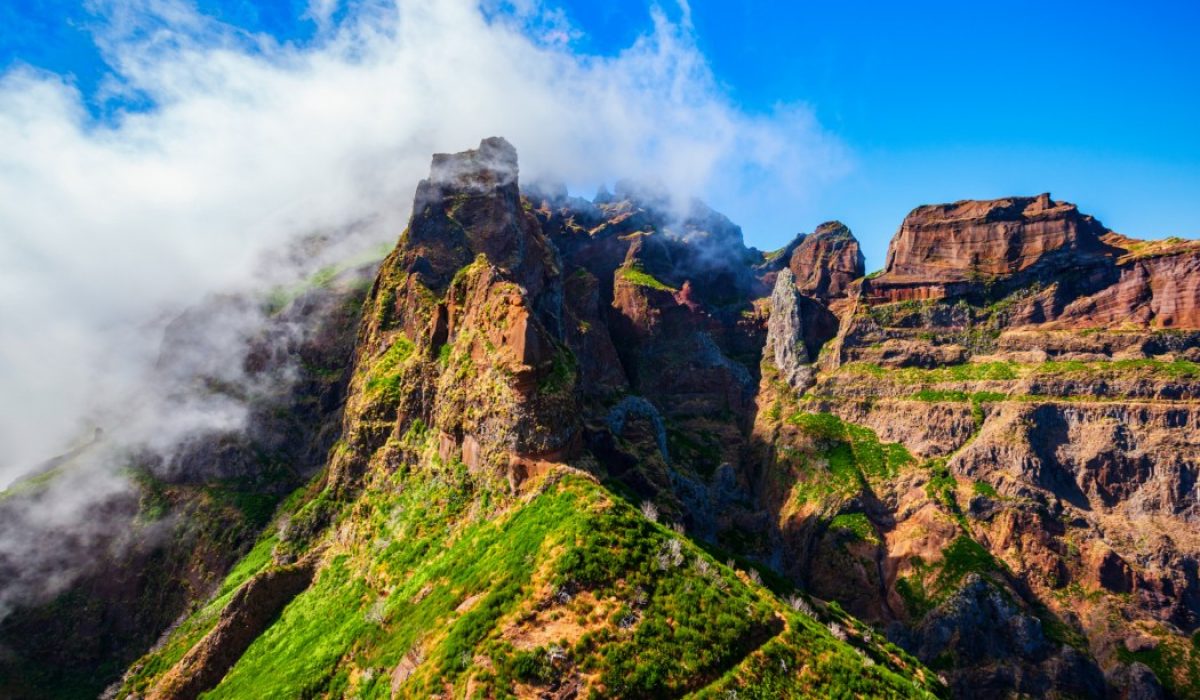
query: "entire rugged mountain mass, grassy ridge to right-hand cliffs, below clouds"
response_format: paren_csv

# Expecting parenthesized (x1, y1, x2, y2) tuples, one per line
(7, 138, 1200, 699)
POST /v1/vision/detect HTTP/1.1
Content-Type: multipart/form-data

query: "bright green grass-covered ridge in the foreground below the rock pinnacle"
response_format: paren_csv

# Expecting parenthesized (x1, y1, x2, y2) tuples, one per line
(125, 463, 936, 698)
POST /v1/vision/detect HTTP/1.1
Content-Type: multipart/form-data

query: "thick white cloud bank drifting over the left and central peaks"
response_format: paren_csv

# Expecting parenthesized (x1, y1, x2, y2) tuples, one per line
(0, 0, 844, 614)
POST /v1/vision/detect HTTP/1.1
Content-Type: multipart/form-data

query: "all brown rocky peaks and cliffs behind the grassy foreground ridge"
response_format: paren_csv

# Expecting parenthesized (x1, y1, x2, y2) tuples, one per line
(84, 139, 1200, 696)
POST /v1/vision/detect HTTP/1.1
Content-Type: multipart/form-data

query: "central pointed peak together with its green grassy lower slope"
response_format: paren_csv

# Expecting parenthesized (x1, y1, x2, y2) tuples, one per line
(116, 139, 940, 698)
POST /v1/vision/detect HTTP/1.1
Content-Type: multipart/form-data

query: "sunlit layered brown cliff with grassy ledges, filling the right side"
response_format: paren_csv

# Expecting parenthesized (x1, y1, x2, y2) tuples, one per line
(787, 196, 1200, 696)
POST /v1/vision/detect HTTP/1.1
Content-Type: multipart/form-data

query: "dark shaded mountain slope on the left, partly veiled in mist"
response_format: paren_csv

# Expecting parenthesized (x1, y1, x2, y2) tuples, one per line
(0, 270, 369, 699)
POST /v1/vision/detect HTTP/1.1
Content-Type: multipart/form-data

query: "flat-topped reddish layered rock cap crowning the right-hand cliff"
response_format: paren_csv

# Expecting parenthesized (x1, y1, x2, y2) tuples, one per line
(862, 195, 1200, 328)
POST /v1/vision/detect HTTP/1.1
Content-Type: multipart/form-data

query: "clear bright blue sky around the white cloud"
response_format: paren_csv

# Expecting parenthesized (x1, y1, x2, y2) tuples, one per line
(0, 0, 1200, 268)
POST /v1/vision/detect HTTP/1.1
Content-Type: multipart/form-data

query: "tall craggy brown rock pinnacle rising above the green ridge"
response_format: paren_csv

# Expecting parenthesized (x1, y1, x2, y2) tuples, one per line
(330, 138, 578, 493)
